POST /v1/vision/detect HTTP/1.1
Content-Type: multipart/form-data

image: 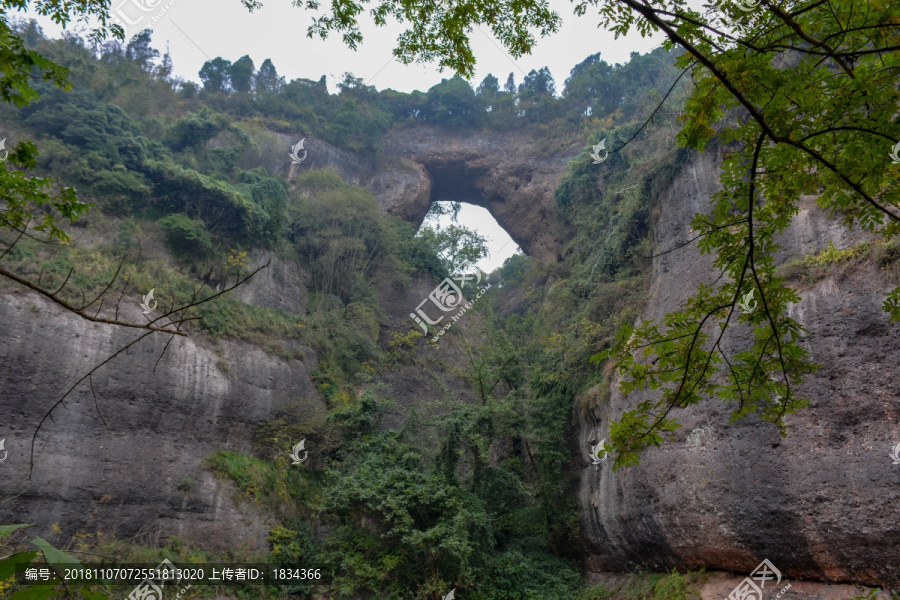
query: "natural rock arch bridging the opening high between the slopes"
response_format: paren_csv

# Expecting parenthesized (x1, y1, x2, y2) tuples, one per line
(368, 127, 574, 263)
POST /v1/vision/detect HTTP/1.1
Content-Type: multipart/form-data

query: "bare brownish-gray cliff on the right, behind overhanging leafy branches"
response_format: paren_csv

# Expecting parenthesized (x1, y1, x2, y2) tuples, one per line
(578, 144, 900, 587)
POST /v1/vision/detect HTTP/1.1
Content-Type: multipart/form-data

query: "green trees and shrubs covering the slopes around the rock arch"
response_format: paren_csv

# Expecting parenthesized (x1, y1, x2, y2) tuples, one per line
(0, 16, 696, 600)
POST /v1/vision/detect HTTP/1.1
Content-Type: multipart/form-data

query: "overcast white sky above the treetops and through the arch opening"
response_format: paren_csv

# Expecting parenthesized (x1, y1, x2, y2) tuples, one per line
(23, 0, 662, 271)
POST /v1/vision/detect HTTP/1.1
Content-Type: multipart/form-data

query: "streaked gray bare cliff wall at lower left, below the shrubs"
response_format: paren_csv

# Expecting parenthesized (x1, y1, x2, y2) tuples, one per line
(0, 282, 318, 552)
